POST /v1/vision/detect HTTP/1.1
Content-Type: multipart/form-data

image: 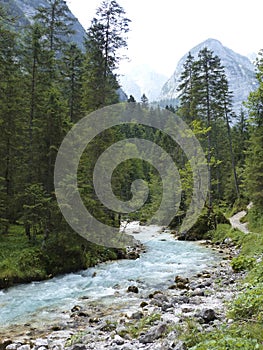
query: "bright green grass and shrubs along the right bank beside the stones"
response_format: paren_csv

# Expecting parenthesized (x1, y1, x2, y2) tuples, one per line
(181, 212, 263, 350)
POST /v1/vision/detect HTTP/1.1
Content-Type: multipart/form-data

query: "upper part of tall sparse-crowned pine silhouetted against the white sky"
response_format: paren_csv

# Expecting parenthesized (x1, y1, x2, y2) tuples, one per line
(83, 0, 130, 111)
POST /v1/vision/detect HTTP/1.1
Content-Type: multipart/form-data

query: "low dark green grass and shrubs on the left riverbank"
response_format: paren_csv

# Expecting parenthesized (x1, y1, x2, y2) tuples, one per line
(0, 225, 118, 288)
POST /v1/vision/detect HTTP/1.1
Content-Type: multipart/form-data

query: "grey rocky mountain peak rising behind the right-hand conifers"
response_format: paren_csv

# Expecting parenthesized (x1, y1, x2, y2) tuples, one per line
(158, 39, 257, 113)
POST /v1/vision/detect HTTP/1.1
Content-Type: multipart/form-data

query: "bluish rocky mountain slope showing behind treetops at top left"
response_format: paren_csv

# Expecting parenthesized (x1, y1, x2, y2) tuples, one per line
(1, 0, 85, 49)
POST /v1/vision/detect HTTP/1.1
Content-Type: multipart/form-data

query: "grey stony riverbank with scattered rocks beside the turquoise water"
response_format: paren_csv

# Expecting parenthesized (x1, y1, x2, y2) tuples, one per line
(0, 242, 242, 350)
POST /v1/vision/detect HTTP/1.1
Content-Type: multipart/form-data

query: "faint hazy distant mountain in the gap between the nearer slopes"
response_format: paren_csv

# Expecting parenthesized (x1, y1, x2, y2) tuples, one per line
(119, 64, 168, 102)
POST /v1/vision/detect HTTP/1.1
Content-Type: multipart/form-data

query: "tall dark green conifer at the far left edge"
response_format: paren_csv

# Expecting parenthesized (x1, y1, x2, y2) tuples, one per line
(0, 7, 25, 230)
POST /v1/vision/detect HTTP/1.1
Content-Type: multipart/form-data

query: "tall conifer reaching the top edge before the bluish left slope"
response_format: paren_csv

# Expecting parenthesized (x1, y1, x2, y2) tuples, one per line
(31, 0, 77, 193)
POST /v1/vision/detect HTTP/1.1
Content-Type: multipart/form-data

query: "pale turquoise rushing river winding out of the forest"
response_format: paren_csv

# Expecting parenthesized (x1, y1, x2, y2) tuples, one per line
(0, 226, 219, 333)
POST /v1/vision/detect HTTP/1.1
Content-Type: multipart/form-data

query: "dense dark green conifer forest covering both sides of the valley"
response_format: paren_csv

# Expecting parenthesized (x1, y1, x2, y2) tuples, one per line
(0, 0, 263, 294)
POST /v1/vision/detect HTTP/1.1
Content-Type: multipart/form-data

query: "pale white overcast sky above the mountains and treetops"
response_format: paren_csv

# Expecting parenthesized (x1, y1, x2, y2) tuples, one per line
(66, 0, 263, 76)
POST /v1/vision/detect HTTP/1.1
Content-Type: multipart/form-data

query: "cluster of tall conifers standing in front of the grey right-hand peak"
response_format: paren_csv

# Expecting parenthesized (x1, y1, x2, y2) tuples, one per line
(178, 48, 239, 208)
